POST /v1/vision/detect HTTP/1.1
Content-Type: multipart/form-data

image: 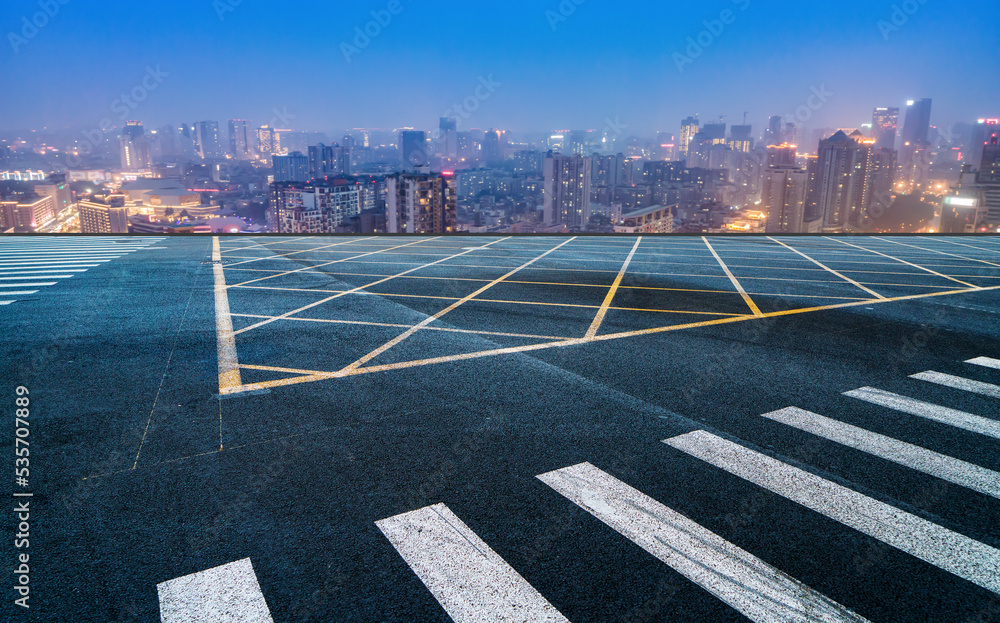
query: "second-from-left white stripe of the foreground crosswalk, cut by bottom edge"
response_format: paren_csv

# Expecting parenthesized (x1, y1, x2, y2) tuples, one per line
(375, 504, 569, 623)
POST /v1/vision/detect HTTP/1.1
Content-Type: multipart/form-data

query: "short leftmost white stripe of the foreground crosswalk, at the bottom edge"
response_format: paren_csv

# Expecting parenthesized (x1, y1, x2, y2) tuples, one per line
(156, 558, 274, 623)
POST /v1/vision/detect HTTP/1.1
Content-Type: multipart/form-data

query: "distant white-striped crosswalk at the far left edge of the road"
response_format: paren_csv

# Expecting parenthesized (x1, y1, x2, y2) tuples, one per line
(0, 236, 164, 306)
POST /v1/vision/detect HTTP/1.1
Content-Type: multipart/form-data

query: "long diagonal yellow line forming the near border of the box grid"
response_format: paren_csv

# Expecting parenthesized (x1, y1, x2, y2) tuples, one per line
(225, 286, 1000, 393)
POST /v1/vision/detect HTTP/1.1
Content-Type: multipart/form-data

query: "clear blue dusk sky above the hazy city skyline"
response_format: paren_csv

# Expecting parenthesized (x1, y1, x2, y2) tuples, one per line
(0, 0, 1000, 133)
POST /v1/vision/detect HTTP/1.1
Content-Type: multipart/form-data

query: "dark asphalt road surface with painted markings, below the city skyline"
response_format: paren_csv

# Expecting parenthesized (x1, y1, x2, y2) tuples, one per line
(0, 237, 1000, 623)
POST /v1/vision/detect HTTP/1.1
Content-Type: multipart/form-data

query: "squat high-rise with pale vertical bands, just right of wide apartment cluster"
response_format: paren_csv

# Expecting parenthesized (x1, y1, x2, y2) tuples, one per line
(386, 173, 458, 234)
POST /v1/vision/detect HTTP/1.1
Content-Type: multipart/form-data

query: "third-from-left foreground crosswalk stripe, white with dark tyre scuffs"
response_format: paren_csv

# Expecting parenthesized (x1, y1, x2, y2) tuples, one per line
(538, 463, 866, 623)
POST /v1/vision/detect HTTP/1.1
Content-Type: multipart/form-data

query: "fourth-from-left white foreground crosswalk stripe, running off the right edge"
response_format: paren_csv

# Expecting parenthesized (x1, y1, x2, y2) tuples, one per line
(664, 431, 1000, 594)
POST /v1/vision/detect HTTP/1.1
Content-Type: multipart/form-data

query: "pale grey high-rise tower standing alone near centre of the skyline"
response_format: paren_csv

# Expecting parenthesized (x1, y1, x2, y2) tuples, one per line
(544, 154, 593, 228)
